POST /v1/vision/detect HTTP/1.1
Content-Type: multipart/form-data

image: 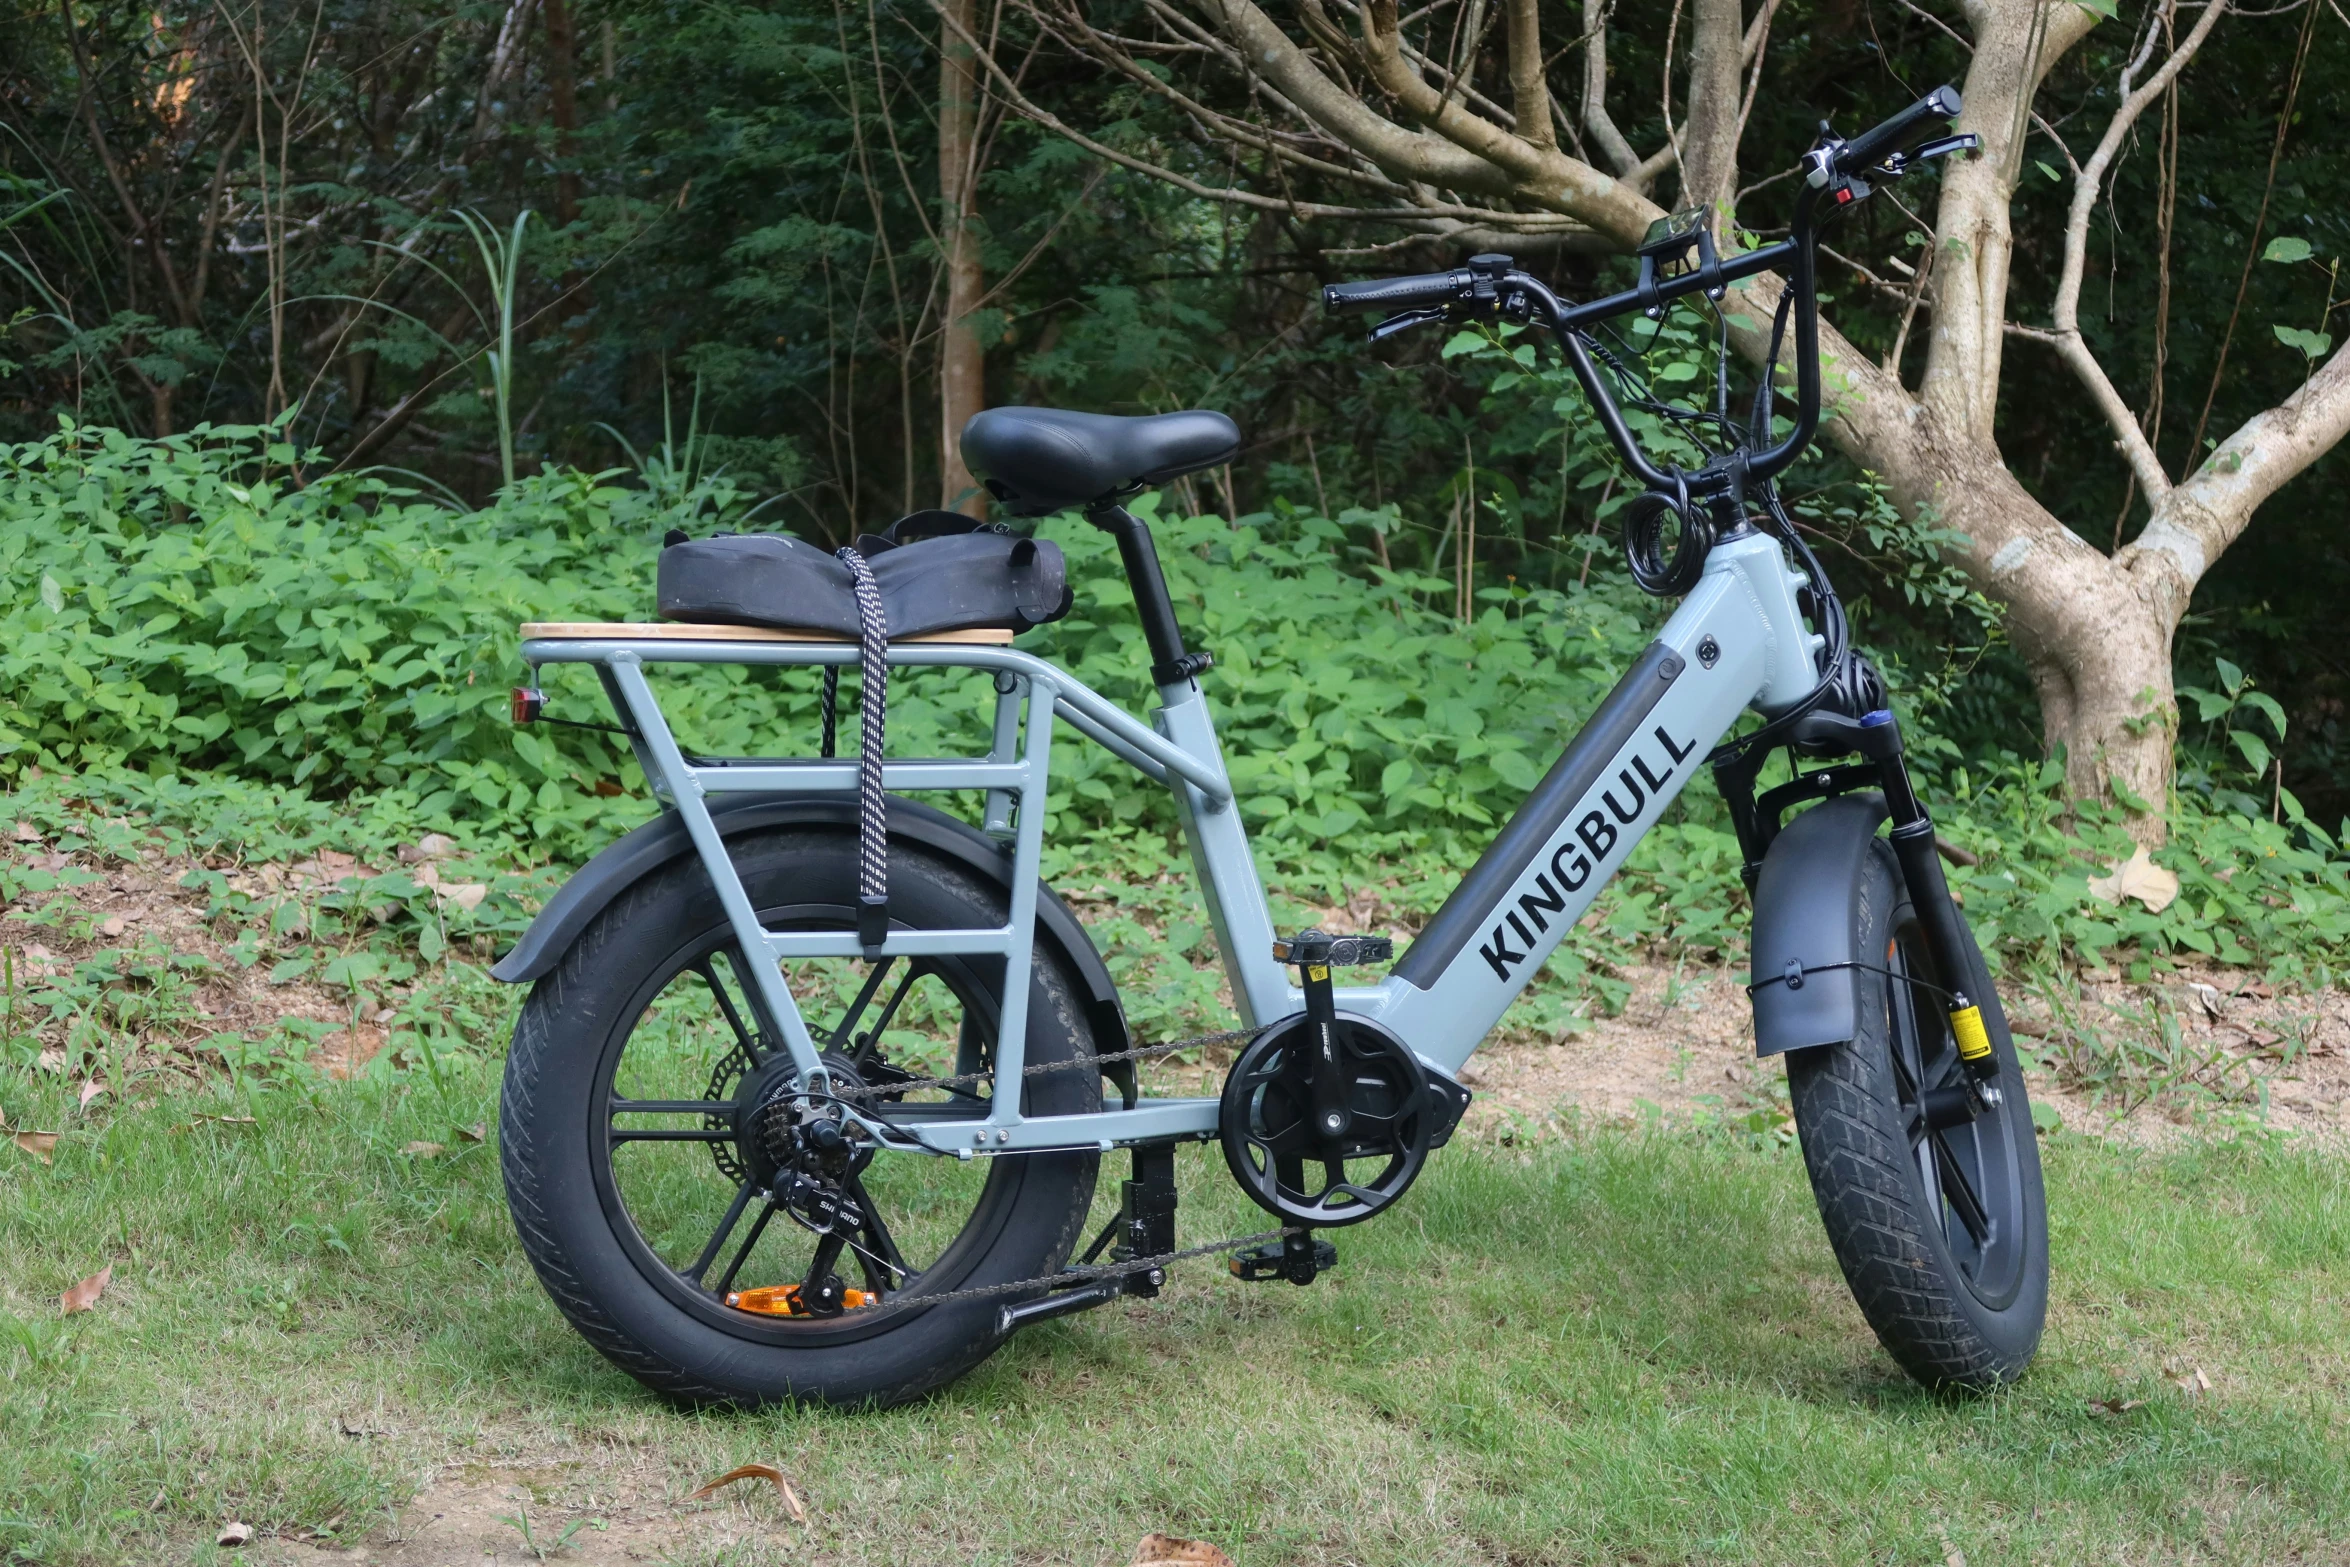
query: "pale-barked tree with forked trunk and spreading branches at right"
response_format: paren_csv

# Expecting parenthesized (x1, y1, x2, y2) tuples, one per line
(977, 0, 2350, 841)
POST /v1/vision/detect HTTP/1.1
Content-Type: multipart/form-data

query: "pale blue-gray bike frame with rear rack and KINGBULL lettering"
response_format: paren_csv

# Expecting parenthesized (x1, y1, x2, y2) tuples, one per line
(522, 531, 1821, 1158)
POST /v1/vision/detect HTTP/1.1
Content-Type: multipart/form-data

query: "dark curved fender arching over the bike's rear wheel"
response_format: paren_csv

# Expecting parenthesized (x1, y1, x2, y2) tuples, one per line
(489, 794, 1130, 1055)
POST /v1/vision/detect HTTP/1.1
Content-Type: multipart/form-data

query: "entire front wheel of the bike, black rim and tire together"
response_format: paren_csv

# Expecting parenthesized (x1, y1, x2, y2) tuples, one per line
(1786, 841, 2049, 1388)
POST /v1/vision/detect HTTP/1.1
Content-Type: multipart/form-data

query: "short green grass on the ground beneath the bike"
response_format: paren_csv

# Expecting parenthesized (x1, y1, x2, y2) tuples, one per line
(0, 1062, 2350, 1567)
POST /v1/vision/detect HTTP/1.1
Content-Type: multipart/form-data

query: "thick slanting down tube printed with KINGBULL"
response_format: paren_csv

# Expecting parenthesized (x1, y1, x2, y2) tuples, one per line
(1372, 584, 1770, 1071)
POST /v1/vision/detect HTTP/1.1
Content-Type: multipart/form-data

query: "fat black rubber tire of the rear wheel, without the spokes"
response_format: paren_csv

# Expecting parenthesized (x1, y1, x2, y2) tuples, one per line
(498, 829, 1102, 1405)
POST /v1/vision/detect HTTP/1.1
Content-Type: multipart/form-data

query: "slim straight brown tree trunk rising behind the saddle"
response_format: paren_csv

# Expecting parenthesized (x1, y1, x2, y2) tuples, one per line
(938, 0, 987, 517)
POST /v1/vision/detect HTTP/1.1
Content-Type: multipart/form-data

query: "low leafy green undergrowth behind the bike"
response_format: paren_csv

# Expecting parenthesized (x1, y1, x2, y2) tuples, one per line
(0, 422, 2350, 1071)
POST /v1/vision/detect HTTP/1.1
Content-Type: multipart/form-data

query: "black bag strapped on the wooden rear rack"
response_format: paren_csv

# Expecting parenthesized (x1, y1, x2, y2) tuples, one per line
(658, 512, 1069, 637)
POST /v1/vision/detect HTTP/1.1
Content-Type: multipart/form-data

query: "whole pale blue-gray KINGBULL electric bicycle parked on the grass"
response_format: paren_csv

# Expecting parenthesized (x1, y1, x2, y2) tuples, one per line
(494, 87, 2047, 1405)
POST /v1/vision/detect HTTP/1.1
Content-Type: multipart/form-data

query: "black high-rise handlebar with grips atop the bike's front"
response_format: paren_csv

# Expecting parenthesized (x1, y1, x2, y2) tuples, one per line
(1323, 87, 1972, 493)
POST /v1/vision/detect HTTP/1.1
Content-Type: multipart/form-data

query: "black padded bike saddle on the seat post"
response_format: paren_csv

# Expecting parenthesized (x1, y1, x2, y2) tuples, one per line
(964, 409, 1241, 517)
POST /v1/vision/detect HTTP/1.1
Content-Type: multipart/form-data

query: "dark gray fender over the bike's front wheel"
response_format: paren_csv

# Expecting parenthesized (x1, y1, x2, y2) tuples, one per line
(1751, 792, 1885, 1055)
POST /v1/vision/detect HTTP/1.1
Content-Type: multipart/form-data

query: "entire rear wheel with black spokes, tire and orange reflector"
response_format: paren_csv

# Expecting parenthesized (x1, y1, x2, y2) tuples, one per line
(501, 829, 1100, 1403)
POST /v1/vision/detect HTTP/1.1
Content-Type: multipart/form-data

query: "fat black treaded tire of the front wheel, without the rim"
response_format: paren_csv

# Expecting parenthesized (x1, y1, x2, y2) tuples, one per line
(1786, 841, 2049, 1391)
